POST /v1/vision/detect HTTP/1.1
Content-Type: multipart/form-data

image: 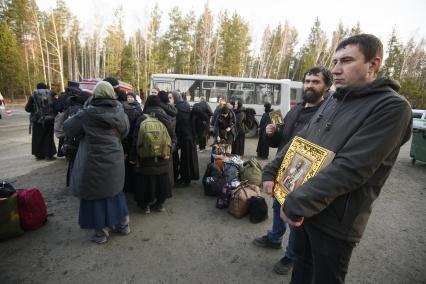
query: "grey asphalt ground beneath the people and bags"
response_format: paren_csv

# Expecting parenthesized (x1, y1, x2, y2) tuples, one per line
(0, 107, 426, 283)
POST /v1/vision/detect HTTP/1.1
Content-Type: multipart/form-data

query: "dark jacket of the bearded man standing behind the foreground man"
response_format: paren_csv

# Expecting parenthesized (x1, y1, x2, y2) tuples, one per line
(263, 102, 323, 152)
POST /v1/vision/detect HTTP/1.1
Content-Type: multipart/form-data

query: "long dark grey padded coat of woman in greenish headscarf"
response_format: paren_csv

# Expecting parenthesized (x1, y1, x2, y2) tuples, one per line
(64, 99, 129, 200)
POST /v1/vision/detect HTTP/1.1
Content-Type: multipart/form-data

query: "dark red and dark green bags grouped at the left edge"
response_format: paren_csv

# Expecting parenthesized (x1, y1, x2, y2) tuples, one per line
(0, 181, 47, 240)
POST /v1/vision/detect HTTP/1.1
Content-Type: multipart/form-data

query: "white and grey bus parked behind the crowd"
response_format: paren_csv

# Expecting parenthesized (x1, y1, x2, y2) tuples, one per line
(151, 74, 303, 137)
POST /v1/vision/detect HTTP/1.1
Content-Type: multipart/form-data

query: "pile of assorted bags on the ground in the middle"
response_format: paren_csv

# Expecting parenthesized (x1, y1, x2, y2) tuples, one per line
(203, 143, 268, 223)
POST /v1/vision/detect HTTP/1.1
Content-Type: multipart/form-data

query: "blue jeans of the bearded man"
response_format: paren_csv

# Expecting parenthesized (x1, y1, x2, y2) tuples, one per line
(267, 198, 295, 260)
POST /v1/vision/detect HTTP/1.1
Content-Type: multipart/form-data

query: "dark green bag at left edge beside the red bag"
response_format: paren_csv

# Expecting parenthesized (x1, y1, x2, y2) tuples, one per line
(0, 193, 24, 240)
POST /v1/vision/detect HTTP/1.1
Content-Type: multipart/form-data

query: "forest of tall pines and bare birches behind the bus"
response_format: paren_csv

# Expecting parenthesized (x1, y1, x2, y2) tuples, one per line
(0, 0, 426, 109)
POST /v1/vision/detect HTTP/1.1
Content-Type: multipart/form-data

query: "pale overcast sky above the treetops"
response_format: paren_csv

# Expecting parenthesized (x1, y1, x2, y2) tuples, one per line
(37, 0, 426, 51)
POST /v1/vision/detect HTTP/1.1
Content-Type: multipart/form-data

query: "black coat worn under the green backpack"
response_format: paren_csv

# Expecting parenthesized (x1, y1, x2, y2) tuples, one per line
(129, 106, 173, 175)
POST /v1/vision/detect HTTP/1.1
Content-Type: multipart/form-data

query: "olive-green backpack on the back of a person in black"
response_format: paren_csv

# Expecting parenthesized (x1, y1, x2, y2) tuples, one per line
(137, 115, 172, 161)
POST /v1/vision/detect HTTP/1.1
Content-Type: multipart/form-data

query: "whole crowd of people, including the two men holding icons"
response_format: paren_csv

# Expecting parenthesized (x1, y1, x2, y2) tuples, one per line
(26, 34, 411, 283)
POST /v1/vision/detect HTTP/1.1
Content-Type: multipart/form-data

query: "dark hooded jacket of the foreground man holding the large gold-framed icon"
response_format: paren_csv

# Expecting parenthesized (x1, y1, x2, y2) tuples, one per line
(263, 78, 411, 242)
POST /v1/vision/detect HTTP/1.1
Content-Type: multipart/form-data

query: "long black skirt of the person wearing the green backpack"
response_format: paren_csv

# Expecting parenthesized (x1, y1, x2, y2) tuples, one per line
(135, 173, 172, 208)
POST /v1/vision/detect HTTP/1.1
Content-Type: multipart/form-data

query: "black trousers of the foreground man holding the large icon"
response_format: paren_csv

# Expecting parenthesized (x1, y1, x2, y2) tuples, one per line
(290, 223, 356, 284)
